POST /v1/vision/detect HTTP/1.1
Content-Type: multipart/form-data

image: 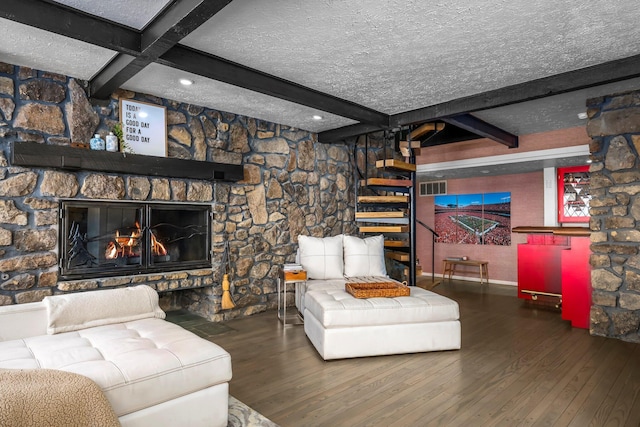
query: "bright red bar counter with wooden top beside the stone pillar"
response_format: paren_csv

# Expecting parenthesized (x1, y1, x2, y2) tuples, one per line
(512, 227, 591, 328)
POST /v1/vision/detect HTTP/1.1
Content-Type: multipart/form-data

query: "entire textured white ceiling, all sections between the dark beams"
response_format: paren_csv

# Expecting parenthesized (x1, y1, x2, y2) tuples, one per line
(0, 0, 640, 177)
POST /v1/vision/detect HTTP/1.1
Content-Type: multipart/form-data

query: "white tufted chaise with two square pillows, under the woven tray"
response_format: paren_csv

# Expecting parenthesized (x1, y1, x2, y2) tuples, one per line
(295, 235, 461, 360)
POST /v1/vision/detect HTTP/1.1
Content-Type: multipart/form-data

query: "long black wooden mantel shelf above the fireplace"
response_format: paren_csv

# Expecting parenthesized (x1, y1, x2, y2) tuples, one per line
(11, 142, 244, 182)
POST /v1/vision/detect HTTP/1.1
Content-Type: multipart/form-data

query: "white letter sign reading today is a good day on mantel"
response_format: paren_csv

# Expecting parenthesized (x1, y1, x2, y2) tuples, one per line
(120, 99, 167, 157)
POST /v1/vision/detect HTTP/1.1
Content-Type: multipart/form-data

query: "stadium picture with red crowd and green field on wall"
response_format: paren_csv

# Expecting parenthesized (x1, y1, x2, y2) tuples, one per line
(434, 192, 511, 246)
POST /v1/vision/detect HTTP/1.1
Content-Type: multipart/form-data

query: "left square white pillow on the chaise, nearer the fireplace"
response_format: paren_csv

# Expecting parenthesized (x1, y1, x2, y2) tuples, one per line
(298, 234, 344, 280)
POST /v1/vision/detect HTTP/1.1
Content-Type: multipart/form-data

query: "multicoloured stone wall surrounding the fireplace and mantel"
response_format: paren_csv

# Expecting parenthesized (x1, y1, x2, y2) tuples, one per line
(0, 64, 363, 320)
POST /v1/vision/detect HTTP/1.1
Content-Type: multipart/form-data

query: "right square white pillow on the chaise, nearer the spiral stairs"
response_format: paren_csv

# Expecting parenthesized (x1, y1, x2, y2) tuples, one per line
(344, 235, 387, 277)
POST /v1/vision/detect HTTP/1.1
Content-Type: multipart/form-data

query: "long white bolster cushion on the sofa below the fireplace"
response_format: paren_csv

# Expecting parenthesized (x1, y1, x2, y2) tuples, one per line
(43, 285, 165, 335)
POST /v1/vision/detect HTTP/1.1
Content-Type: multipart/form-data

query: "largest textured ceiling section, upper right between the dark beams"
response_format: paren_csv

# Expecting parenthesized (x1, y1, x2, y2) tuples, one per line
(182, 0, 640, 114)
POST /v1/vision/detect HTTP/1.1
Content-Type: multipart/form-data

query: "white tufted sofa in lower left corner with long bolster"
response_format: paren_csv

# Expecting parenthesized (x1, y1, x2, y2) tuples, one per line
(0, 285, 232, 427)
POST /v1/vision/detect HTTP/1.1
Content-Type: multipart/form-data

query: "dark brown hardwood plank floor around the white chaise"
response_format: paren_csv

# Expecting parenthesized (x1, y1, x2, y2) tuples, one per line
(172, 281, 640, 426)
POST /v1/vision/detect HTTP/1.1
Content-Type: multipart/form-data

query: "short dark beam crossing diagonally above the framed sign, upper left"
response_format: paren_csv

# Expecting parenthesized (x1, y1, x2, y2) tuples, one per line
(89, 0, 231, 99)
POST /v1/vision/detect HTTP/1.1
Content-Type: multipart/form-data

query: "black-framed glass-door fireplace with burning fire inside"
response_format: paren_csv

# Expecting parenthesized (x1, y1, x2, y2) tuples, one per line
(59, 200, 211, 279)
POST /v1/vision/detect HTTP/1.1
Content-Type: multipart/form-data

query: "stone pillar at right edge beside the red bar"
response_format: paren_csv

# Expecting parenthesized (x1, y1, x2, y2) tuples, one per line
(587, 91, 640, 342)
